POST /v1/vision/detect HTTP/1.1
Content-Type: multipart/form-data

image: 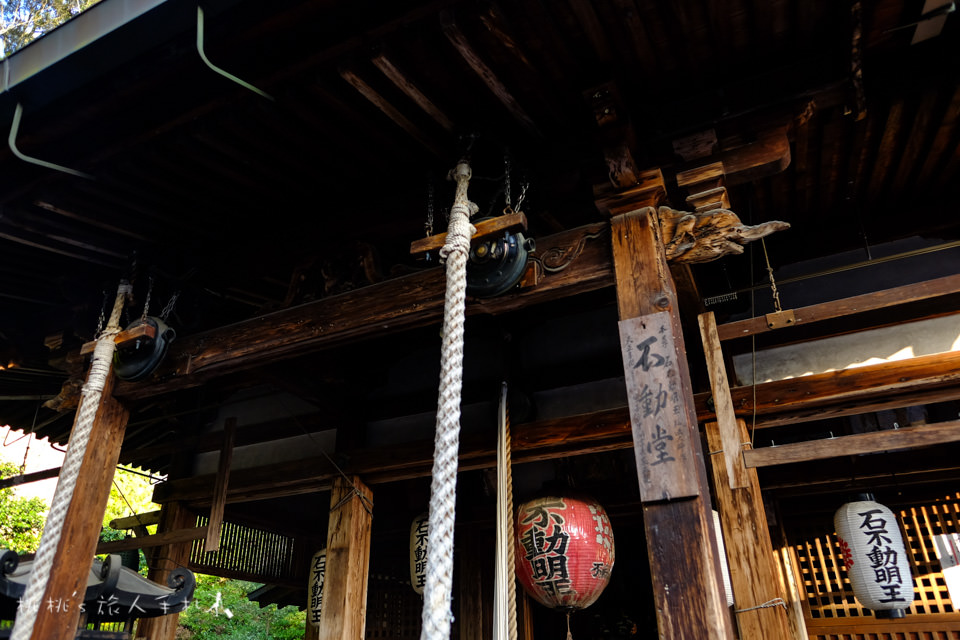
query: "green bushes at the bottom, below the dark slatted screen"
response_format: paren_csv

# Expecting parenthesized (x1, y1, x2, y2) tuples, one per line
(177, 575, 306, 640)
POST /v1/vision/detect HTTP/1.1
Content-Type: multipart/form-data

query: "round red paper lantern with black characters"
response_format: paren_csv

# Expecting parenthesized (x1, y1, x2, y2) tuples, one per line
(516, 496, 614, 611)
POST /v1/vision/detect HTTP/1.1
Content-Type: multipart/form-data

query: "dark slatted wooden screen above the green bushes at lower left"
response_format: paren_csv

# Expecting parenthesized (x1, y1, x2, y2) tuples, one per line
(190, 516, 296, 583)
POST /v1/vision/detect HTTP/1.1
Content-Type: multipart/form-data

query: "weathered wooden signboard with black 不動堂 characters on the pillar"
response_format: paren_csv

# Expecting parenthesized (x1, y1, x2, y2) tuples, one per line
(620, 311, 699, 502)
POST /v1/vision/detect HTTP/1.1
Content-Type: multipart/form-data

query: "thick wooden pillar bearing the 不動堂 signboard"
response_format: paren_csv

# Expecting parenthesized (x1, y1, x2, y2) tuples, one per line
(611, 208, 733, 640)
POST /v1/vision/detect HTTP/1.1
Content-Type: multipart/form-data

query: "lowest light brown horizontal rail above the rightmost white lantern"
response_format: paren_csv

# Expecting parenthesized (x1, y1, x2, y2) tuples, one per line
(743, 420, 960, 467)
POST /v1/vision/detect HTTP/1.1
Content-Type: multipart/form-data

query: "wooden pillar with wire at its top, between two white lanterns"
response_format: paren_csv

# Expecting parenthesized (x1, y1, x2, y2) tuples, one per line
(319, 476, 373, 640)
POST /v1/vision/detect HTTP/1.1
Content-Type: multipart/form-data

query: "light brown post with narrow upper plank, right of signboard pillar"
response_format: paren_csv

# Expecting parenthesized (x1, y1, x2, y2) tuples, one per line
(700, 313, 792, 640)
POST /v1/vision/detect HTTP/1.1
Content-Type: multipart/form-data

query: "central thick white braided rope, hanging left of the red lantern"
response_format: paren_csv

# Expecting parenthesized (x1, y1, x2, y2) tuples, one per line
(420, 162, 476, 640)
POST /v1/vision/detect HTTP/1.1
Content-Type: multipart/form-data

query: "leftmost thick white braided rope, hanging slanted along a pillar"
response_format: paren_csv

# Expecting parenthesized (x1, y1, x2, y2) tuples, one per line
(10, 283, 131, 640)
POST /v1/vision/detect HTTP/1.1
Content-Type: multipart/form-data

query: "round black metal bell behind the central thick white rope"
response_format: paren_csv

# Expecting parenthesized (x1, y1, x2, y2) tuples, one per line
(467, 222, 536, 298)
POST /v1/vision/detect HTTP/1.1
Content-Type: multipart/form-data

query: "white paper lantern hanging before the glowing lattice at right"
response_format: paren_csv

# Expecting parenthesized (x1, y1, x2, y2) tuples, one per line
(833, 500, 913, 617)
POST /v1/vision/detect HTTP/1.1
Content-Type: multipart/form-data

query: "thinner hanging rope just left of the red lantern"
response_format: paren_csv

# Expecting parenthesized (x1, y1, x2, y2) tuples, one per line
(493, 382, 517, 640)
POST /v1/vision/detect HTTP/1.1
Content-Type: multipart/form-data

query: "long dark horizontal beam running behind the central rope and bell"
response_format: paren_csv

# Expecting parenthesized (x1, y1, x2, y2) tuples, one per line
(115, 223, 613, 400)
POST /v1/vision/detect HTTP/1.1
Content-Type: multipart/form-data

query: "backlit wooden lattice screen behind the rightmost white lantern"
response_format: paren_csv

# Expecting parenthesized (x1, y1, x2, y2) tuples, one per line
(790, 493, 960, 640)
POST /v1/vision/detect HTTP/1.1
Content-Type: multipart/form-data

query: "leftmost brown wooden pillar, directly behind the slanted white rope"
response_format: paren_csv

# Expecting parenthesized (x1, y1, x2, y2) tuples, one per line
(31, 375, 130, 640)
